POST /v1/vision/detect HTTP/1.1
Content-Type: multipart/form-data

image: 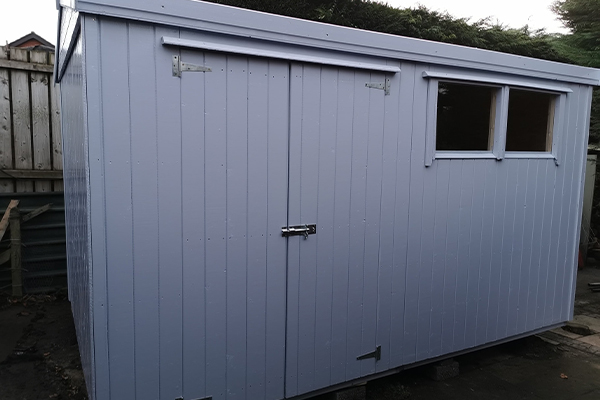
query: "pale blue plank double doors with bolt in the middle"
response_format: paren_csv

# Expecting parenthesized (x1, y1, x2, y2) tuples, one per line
(180, 51, 399, 399)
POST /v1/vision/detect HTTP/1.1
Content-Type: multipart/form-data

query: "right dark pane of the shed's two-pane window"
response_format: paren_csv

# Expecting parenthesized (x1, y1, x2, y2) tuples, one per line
(506, 89, 556, 152)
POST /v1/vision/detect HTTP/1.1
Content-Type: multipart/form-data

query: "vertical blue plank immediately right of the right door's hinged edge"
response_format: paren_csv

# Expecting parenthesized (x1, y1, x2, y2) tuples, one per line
(378, 68, 400, 371)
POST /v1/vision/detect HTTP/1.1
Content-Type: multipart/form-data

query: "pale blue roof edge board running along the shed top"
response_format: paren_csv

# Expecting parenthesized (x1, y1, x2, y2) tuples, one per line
(57, 0, 600, 85)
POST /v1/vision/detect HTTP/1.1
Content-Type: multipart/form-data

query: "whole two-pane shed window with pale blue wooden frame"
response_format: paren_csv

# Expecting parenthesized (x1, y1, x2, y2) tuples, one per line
(423, 71, 572, 166)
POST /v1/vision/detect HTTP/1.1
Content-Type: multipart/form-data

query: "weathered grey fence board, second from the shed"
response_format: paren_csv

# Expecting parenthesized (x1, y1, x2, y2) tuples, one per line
(30, 51, 52, 192)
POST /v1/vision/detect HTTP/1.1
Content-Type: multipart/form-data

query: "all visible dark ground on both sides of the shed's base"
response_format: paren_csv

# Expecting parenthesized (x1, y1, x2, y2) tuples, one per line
(0, 268, 600, 400)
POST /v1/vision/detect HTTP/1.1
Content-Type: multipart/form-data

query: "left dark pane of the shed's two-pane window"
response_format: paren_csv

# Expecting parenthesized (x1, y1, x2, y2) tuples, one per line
(436, 82, 497, 151)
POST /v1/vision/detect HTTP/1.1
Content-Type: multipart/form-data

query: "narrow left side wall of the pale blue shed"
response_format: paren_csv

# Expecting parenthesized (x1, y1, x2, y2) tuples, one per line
(61, 36, 95, 399)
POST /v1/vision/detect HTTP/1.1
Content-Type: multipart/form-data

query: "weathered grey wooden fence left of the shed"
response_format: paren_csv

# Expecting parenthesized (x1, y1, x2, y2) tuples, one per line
(0, 46, 63, 193)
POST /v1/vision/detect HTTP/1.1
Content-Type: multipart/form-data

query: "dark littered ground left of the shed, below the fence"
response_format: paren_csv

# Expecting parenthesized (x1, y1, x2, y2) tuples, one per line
(0, 294, 87, 400)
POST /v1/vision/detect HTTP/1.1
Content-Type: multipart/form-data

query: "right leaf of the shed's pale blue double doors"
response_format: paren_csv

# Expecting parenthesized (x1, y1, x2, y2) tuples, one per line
(286, 64, 397, 397)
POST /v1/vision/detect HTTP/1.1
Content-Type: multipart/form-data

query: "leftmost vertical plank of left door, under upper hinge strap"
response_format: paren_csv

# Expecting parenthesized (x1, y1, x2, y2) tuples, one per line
(181, 43, 207, 399)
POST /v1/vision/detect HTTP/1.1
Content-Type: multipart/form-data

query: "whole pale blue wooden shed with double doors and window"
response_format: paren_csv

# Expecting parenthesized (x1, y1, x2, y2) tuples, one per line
(56, 0, 600, 400)
